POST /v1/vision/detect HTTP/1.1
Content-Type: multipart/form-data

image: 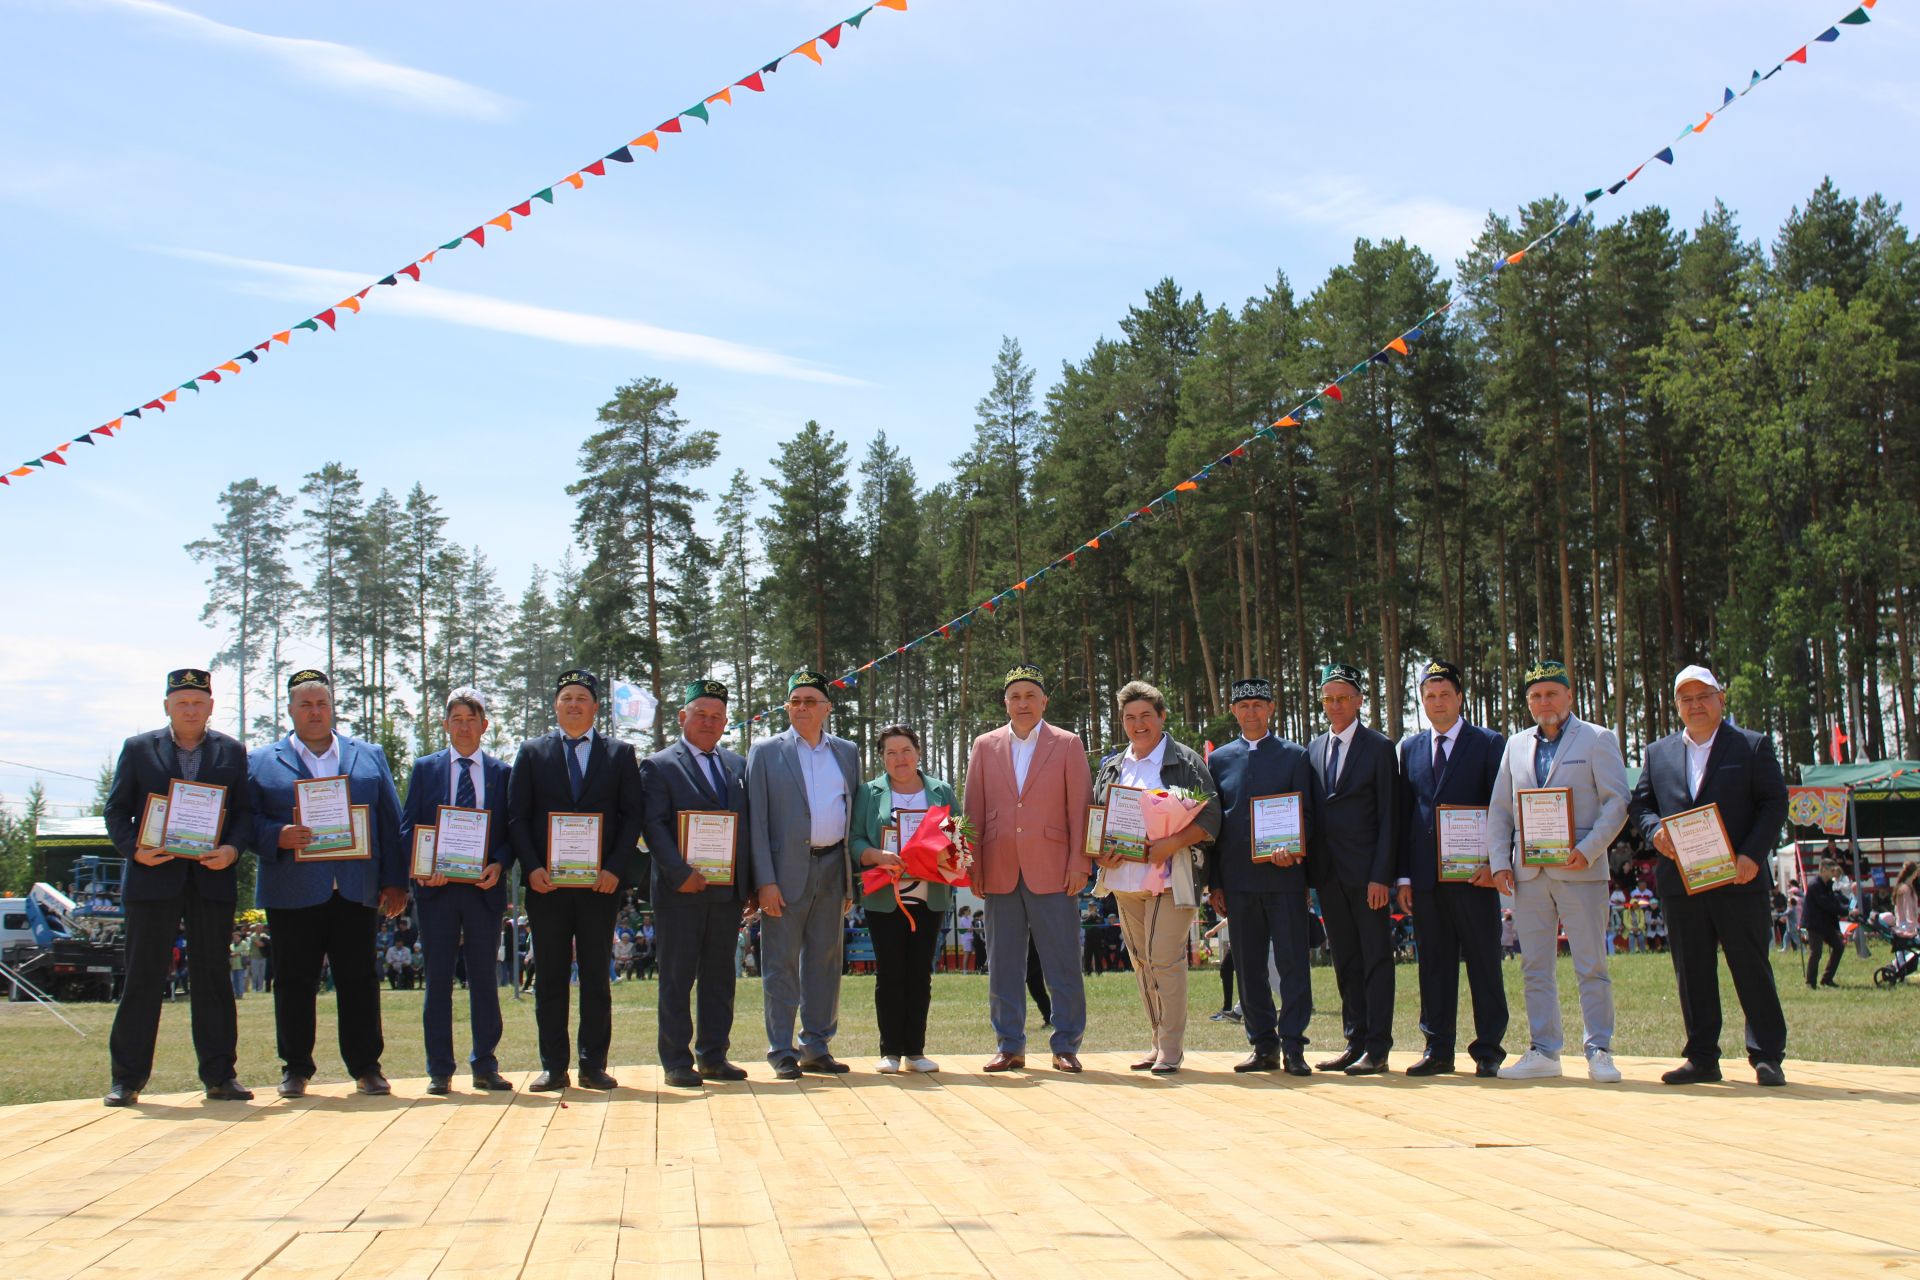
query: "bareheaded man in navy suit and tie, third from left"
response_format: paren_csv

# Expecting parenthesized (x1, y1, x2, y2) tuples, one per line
(399, 687, 513, 1096)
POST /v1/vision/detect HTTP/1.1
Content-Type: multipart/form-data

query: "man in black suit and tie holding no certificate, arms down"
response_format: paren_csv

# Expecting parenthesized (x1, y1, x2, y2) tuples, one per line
(1308, 662, 1398, 1075)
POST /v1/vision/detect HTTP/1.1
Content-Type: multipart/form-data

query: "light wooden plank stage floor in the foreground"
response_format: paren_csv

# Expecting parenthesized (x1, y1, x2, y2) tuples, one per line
(0, 1054, 1920, 1280)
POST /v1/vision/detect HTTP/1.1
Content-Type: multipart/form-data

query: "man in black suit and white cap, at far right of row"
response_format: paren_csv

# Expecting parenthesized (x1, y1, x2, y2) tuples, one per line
(1632, 666, 1788, 1084)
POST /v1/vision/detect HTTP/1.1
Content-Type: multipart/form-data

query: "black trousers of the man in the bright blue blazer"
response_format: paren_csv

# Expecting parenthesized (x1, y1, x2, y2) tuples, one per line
(268, 892, 386, 1079)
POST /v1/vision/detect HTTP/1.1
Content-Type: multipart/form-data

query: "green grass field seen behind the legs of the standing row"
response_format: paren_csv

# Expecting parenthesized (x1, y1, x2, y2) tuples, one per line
(0, 948, 1920, 1103)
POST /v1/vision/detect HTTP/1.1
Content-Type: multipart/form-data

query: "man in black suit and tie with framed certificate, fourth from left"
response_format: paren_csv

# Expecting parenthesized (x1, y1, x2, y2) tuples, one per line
(507, 670, 645, 1092)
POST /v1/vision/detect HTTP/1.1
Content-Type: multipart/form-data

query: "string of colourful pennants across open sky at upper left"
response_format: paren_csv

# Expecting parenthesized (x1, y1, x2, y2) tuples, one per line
(0, 0, 906, 486)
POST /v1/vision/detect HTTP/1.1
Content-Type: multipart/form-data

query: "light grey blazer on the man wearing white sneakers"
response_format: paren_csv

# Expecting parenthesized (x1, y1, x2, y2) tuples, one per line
(1486, 716, 1628, 881)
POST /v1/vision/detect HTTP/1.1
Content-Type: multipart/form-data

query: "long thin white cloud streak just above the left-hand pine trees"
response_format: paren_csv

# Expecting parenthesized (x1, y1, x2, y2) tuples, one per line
(169, 249, 864, 386)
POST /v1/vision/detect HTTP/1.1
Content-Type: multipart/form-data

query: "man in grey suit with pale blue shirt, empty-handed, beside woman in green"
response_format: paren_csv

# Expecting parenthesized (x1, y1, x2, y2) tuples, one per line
(747, 672, 860, 1080)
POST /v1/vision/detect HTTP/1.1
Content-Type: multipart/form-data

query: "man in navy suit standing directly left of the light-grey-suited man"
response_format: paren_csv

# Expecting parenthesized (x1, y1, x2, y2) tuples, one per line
(1396, 660, 1507, 1077)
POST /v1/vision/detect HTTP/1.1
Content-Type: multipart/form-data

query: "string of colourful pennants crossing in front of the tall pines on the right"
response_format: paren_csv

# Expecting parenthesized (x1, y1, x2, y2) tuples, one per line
(728, 0, 1880, 731)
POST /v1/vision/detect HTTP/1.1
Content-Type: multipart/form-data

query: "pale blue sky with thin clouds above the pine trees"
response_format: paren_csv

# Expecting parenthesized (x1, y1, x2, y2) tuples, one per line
(0, 0, 1920, 817)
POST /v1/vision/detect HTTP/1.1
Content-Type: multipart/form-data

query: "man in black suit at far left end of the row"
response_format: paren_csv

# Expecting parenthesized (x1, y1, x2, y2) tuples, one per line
(106, 668, 253, 1107)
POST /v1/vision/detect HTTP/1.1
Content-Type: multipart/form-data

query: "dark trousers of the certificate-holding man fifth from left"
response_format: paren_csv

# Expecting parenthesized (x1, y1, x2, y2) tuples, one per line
(653, 890, 741, 1069)
